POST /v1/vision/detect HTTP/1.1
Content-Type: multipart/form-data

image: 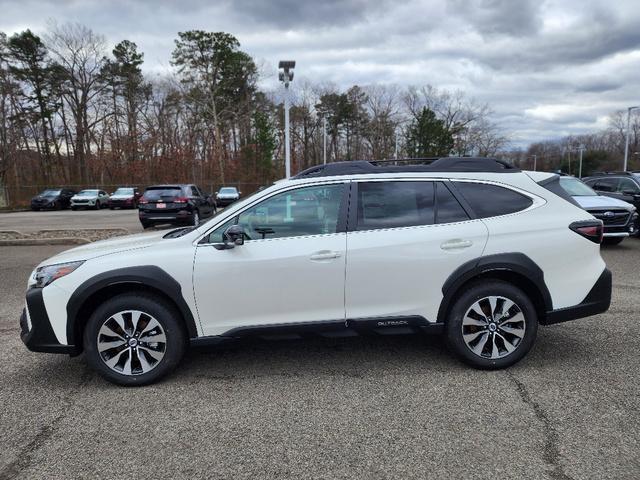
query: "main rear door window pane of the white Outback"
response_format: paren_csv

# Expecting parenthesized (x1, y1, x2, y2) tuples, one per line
(356, 181, 435, 230)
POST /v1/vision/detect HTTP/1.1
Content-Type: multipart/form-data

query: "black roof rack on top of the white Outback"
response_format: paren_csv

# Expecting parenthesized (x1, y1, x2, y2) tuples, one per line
(293, 157, 520, 179)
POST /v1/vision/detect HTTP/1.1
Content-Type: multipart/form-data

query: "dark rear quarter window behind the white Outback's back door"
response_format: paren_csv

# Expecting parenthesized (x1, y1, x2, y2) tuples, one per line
(454, 182, 533, 218)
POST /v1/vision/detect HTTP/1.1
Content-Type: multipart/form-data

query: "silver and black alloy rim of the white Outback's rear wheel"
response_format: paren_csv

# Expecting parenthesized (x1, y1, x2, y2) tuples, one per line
(462, 296, 526, 360)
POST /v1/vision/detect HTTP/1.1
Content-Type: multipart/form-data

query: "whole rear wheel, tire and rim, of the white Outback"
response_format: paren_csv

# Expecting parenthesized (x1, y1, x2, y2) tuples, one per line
(446, 280, 538, 369)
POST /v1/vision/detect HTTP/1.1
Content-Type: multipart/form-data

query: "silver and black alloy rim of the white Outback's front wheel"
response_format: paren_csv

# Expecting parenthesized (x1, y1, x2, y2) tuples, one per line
(97, 310, 167, 375)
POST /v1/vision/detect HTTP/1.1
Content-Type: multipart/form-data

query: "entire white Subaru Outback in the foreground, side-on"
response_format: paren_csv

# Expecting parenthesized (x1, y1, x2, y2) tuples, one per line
(20, 158, 611, 385)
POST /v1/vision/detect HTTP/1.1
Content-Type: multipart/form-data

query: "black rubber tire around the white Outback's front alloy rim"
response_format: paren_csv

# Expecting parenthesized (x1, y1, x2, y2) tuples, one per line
(83, 293, 187, 386)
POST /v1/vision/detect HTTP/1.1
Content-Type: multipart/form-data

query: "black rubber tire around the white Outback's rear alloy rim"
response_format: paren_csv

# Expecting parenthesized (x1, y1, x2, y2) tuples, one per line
(446, 280, 538, 370)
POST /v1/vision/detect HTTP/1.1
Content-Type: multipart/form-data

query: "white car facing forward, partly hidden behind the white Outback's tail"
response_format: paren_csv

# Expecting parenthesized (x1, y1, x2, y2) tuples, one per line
(560, 176, 638, 245)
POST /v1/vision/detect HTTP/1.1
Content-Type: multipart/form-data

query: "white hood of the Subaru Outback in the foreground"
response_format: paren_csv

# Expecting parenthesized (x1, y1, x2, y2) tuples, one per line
(38, 230, 168, 266)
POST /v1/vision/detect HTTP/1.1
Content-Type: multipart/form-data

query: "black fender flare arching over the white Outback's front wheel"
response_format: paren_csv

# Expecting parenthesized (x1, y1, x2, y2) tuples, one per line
(67, 265, 198, 344)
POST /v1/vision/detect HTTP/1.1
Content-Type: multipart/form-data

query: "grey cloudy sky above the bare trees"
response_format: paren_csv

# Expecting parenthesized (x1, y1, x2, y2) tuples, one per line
(0, 0, 640, 146)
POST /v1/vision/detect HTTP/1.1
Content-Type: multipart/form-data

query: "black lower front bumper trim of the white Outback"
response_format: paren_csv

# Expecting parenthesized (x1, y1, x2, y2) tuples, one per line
(20, 288, 79, 355)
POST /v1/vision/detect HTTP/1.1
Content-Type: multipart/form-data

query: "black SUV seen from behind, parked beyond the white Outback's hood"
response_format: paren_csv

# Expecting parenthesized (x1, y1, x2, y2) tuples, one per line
(138, 185, 216, 228)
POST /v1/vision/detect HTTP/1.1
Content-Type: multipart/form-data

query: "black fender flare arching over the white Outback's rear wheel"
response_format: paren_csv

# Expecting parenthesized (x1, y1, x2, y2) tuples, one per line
(438, 252, 553, 322)
